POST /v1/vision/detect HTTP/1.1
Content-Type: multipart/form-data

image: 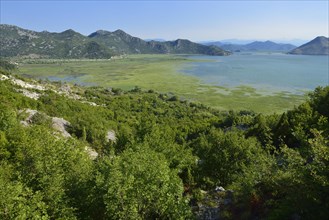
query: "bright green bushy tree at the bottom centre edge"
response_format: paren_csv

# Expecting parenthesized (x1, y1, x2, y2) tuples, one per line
(98, 148, 190, 219)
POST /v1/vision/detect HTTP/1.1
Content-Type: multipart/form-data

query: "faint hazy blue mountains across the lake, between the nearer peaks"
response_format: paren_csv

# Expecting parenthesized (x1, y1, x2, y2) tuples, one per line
(206, 41, 296, 52)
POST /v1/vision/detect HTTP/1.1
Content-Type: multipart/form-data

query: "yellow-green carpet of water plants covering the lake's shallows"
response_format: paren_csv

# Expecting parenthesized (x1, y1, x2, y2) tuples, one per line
(19, 55, 305, 114)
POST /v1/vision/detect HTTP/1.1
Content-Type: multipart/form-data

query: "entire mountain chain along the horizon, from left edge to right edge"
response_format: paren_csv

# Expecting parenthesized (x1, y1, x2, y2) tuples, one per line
(0, 24, 329, 58)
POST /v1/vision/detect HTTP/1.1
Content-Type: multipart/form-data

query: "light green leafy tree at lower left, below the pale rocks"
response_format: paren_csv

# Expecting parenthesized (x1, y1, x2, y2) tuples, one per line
(3, 121, 92, 219)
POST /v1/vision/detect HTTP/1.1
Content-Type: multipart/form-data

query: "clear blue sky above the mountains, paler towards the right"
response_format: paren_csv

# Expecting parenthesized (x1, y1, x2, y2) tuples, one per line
(0, 0, 329, 41)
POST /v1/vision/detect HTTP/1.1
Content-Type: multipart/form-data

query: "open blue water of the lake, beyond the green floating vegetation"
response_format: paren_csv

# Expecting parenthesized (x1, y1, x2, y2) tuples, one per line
(181, 53, 329, 94)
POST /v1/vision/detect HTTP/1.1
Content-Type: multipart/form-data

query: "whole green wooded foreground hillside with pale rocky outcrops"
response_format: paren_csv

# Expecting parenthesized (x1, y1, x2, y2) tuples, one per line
(0, 61, 329, 219)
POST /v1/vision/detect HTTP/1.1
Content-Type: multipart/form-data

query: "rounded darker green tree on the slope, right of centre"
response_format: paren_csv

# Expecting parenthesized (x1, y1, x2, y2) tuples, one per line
(194, 128, 263, 188)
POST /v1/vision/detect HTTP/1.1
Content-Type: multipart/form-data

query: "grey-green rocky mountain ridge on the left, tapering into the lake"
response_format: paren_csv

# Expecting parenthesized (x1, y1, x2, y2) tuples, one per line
(0, 24, 230, 58)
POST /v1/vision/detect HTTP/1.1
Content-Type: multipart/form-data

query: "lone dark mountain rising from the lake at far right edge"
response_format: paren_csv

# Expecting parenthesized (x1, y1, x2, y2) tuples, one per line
(289, 36, 329, 55)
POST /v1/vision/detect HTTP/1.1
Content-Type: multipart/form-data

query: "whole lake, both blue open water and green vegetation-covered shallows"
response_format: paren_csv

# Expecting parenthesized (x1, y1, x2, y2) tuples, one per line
(19, 53, 329, 111)
